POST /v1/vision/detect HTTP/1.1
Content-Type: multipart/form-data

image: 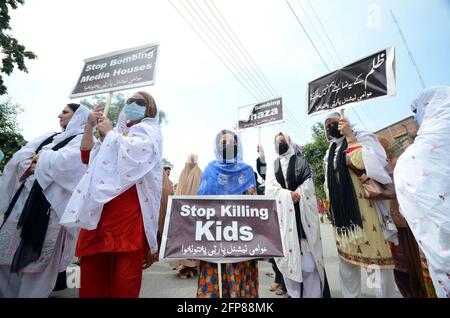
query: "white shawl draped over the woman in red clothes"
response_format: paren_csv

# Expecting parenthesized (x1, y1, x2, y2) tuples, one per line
(61, 110, 163, 253)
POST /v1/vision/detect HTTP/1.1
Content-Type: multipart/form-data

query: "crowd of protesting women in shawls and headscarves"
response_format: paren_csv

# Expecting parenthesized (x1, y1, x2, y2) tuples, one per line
(0, 86, 450, 298)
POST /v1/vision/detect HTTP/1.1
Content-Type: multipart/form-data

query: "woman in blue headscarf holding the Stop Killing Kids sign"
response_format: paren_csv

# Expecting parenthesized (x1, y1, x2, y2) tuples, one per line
(197, 130, 258, 298)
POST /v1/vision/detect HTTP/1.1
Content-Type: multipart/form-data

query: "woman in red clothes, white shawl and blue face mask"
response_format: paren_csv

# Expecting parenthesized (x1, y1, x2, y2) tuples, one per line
(61, 92, 162, 297)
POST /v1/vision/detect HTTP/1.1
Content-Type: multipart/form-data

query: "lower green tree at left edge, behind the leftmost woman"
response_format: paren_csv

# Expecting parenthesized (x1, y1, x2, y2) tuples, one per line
(0, 98, 26, 171)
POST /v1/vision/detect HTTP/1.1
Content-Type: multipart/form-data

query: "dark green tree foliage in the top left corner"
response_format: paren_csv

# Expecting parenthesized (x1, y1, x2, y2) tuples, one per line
(0, 0, 36, 95)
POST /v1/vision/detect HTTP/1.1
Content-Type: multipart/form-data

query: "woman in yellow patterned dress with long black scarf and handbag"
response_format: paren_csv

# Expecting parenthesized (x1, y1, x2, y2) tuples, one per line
(324, 113, 397, 298)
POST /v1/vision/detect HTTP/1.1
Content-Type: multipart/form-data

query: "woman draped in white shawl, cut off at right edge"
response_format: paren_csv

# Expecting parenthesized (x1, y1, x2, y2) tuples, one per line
(394, 86, 450, 298)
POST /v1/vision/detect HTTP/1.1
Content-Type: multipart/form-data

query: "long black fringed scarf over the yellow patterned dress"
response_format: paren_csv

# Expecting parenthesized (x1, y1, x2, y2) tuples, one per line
(327, 138, 363, 235)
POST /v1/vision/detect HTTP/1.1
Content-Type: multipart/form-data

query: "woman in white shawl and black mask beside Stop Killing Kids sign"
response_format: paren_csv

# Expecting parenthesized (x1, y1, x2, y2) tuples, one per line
(265, 133, 329, 298)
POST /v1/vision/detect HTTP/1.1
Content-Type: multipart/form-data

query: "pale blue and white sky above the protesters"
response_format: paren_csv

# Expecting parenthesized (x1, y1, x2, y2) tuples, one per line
(6, 0, 450, 180)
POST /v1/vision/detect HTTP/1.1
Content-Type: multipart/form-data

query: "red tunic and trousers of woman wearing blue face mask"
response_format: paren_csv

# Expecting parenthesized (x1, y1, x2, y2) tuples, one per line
(75, 150, 148, 298)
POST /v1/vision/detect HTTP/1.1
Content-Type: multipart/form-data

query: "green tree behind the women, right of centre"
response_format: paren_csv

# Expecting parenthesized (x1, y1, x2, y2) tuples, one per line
(302, 123, 329, 200)
